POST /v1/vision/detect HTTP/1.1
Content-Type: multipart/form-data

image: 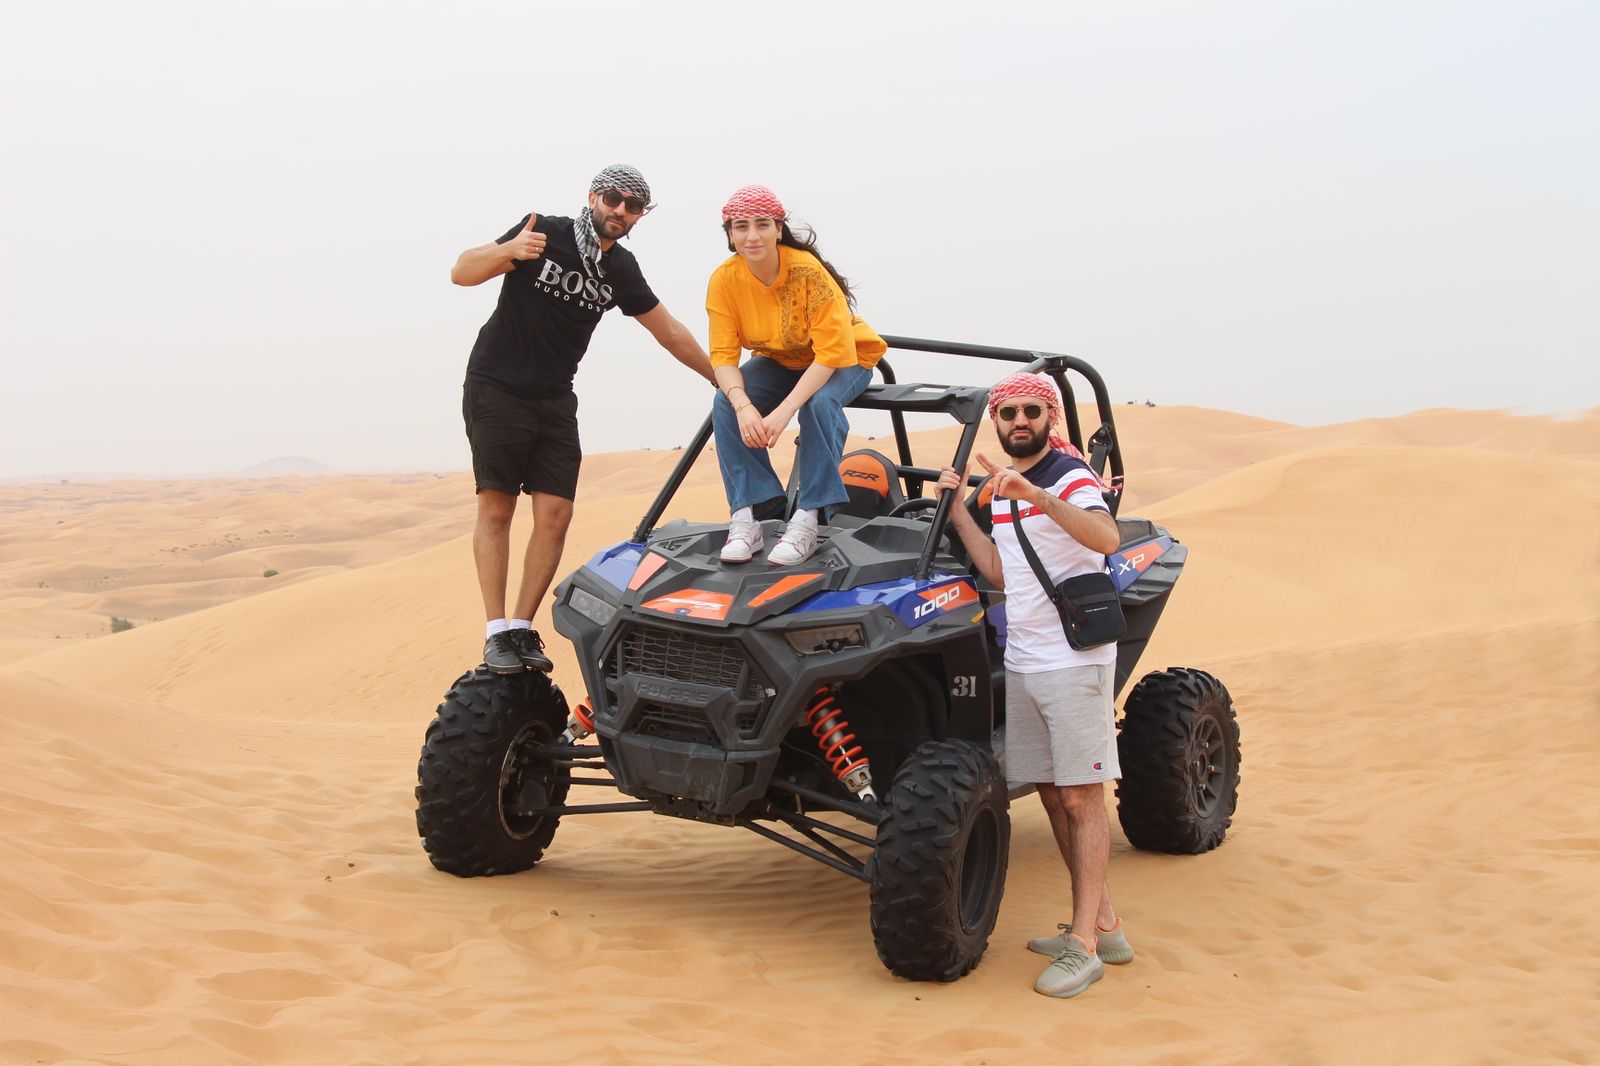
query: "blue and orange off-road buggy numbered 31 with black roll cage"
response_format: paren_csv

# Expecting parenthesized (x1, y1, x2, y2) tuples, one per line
(416, 336, 1238, 981)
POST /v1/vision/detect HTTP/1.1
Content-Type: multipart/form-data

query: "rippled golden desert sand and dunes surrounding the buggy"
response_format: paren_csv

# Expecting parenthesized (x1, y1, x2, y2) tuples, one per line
(0, 405, 1600, 1066)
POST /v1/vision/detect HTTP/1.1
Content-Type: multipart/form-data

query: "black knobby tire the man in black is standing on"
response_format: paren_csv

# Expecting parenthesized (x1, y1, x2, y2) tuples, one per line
(416, 666, 568, 877)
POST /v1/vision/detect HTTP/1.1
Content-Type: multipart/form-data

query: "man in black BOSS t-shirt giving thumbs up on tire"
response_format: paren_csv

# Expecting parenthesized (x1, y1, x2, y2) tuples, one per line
(450, 163, 715, 674)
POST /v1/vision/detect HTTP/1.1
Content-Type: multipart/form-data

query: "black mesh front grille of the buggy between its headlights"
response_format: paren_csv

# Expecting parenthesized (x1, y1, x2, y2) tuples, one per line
(605, 624, 771, 743)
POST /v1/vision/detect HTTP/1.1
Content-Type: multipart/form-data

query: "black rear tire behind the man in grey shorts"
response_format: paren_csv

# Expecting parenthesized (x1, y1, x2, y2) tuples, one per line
(1117, 667, 1238, 855)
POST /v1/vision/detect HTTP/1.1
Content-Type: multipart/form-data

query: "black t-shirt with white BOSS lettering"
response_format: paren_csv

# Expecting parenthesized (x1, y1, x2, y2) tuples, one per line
(467, 214, 661, 400)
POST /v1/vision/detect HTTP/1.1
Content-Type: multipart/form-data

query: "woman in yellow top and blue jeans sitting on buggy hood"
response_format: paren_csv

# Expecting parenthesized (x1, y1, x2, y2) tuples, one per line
(706, 186, 888, 565)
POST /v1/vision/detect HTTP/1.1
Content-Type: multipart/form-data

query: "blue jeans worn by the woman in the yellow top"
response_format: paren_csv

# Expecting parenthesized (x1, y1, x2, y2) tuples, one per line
(710, 355, 872, 522)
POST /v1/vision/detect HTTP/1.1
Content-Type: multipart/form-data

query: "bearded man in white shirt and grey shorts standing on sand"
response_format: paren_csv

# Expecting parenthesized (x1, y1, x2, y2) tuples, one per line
(939, 373, 1133, 999)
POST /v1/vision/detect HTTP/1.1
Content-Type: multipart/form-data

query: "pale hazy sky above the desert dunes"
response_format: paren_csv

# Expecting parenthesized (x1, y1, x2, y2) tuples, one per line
(0, 0, 1600, 475)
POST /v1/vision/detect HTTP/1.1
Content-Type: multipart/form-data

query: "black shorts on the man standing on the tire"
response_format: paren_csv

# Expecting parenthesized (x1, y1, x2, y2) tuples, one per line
(461, 378, 584, 499)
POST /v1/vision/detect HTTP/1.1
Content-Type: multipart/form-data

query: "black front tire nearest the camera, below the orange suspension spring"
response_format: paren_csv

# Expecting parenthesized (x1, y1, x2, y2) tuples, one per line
(872, 739, 1011, 981)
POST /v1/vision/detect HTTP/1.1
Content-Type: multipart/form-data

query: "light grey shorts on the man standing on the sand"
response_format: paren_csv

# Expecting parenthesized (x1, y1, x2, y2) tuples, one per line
(1005, 666, 1122, 787)
